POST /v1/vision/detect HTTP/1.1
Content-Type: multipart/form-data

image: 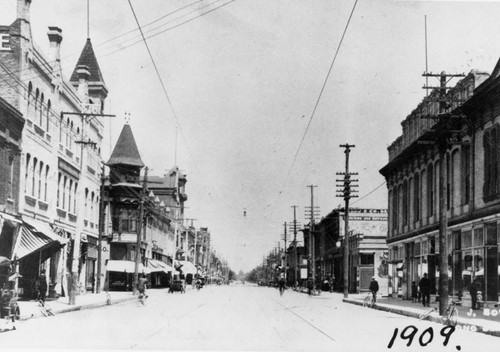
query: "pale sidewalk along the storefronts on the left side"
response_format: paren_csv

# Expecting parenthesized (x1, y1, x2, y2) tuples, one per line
(18, 288, 172, 320)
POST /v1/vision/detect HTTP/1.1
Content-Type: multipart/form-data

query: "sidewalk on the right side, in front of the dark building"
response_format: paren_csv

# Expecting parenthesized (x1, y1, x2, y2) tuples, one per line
(342, 293, 500, 337)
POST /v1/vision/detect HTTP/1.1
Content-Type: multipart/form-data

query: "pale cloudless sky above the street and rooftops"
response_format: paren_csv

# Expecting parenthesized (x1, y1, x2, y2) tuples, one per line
(0, 0, 500, 272)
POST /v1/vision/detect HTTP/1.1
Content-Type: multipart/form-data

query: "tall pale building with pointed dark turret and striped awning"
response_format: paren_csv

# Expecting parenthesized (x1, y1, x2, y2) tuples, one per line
(0, 0, 108, 303)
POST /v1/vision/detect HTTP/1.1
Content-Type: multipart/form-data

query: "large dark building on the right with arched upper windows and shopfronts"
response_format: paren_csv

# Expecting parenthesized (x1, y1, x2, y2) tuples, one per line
(380, 61, 500, 307)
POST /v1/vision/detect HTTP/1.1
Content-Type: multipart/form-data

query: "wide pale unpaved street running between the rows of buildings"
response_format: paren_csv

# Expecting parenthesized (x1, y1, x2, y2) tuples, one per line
(0, 284, 500, 351)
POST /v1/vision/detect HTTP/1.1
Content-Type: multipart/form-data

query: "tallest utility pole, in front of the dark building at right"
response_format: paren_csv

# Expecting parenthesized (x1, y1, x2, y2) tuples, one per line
(422, 71, 465, 315)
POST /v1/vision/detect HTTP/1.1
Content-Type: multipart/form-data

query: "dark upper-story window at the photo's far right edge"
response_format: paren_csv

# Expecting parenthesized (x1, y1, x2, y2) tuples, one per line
(483, 124, 500, 202)
